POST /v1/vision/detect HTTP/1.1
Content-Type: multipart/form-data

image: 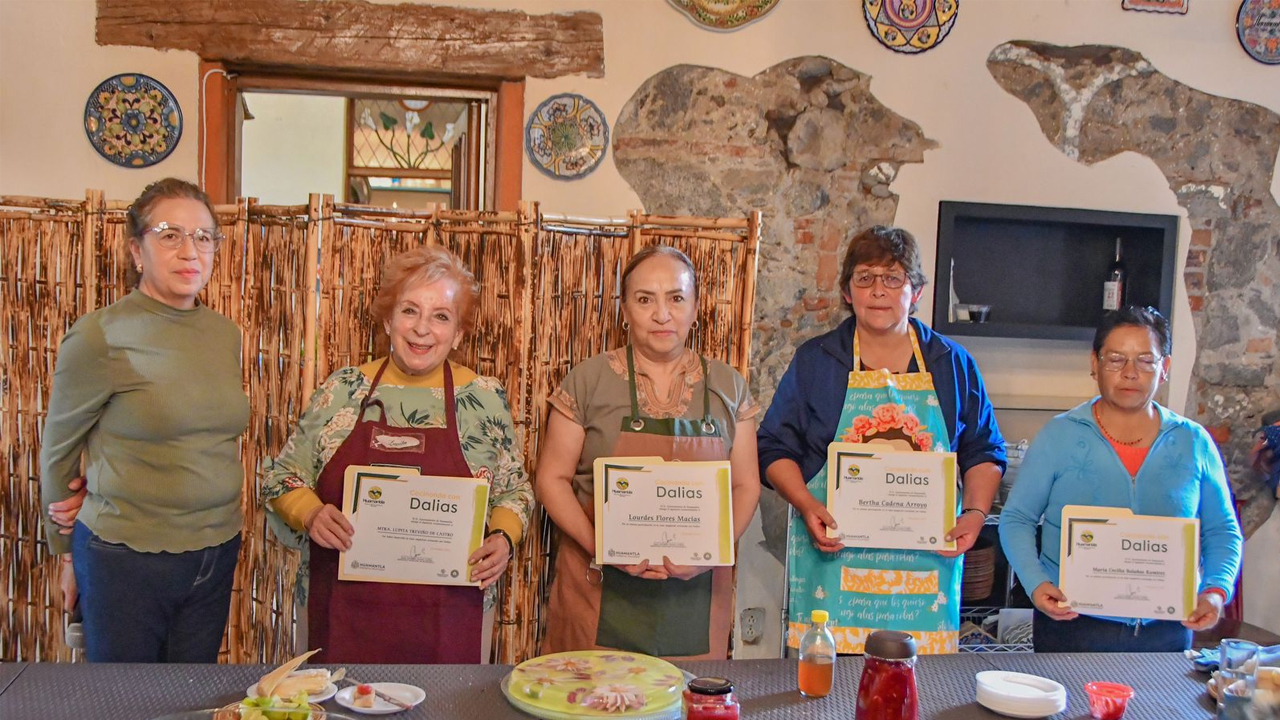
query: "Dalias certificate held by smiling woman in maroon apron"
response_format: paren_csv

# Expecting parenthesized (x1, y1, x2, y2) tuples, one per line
(338, 465, 489, 585)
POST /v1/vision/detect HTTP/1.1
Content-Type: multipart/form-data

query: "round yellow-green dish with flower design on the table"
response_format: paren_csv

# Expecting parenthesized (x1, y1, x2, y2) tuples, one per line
(502, 651, 686, 720)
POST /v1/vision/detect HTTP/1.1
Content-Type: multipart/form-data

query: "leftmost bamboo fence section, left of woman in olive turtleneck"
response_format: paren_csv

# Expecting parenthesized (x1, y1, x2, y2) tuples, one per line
(0, 192, 101, 660)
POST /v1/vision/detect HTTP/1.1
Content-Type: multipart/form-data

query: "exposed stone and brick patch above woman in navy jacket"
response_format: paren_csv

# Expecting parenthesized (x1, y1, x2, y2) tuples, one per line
(613, 56, 934, 406)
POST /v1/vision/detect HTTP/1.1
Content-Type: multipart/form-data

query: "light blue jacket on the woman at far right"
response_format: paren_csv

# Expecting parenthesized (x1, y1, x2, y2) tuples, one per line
(1000, 400, 1244, 620)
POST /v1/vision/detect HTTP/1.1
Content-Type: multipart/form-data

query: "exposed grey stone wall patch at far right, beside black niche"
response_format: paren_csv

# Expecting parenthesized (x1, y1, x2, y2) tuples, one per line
(987, 41, 1280, 534)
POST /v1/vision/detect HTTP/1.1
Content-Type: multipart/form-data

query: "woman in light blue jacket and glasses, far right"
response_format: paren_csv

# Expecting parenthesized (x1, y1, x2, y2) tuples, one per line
(1000, 306, 1243, 652)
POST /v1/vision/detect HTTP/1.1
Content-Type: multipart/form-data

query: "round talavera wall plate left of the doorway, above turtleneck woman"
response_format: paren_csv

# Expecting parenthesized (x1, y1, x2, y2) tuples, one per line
(84, 73, 182, 168)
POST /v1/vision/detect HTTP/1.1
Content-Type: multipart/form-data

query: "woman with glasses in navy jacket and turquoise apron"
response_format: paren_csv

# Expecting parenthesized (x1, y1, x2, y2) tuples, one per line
(759, 225, 1005, 653)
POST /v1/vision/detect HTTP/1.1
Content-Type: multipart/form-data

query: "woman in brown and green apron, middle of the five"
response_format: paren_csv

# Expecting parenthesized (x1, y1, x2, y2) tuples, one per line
(538, 246, 760, 659)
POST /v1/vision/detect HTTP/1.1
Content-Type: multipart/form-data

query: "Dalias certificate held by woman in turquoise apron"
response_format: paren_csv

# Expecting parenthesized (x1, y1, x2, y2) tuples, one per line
(827, 442, 956, 551)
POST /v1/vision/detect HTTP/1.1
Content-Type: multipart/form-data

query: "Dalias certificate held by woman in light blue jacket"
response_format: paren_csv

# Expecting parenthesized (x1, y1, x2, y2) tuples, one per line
(1059, 505, 1199, 620)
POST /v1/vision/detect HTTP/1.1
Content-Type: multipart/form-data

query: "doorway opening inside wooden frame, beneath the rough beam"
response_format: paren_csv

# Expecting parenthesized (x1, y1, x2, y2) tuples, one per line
(229, 74, 498, 210)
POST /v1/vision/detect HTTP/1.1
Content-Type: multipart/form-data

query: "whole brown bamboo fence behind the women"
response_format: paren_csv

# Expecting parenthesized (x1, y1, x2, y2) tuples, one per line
(0, 191, 759, 662)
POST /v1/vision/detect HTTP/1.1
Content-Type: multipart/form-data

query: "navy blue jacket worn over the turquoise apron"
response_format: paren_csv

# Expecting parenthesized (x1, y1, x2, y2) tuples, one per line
(755, 318, 1006, 487)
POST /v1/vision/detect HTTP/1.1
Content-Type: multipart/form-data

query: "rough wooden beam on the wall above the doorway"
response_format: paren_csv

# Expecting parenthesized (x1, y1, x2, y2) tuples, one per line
(97, 0, 604, 79)
